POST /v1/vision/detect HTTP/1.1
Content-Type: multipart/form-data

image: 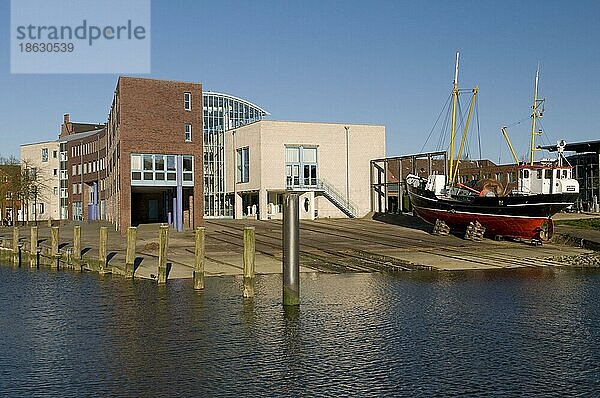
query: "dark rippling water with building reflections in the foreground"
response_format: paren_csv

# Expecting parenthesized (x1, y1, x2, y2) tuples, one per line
(0, 267, 600, 396)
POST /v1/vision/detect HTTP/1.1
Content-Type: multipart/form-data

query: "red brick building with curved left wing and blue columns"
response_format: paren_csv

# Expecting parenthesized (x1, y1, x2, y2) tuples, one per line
(59, 76, 203, 232)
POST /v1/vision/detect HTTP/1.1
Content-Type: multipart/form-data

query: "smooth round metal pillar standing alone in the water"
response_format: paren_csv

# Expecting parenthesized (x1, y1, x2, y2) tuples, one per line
(283, 193, 300, 306)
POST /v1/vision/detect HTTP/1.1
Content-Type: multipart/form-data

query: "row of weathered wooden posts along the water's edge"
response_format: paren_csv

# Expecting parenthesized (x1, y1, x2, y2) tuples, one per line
(2, 225, 256, 298)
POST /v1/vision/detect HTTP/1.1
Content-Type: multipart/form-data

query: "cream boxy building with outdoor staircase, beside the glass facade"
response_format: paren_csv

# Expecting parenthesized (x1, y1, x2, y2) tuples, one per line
(224, 120, 385, 219)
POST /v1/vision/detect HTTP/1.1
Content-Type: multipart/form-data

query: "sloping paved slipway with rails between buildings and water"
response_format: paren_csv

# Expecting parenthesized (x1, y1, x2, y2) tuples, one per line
(0, 211, 600, 279)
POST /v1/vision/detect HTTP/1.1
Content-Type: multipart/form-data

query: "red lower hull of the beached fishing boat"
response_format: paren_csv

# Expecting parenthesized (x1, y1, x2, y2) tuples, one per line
(414, 206, 552, 239)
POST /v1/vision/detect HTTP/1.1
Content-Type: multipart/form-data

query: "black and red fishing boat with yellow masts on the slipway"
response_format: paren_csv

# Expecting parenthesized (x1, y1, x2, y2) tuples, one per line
(406, 52, 579, 242)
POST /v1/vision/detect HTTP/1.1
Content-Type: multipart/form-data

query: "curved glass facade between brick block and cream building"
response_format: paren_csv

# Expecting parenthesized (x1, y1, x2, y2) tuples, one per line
(202, 91, 269, 218)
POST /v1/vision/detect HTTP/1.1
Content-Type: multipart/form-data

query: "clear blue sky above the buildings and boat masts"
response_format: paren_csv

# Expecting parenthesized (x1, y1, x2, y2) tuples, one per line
(0, 0, 600, 162)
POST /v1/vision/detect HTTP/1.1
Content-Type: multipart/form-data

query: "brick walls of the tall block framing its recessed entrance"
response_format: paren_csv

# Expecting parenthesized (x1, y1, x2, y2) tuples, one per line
(106, 77, 204, 232)
